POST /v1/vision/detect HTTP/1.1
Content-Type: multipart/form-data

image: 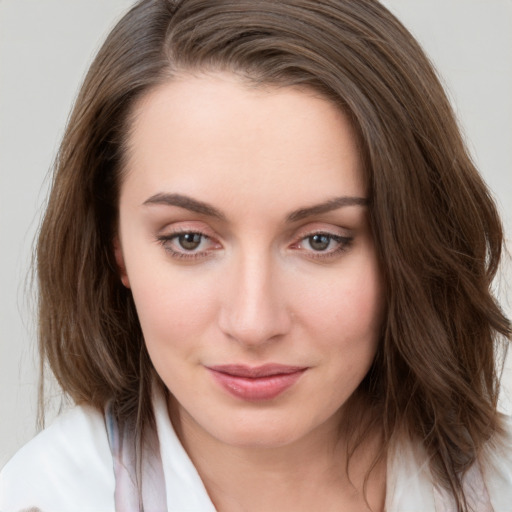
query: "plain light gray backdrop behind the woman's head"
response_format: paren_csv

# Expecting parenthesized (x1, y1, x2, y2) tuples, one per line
(0, 0, 512, 467)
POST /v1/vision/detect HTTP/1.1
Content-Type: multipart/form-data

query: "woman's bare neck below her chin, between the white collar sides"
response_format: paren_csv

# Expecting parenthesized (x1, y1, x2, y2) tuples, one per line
(171, 400, 386, 512)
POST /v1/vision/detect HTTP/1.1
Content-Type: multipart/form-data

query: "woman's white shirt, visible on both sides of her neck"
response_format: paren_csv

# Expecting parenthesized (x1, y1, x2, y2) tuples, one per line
(0, 388, 512, 512)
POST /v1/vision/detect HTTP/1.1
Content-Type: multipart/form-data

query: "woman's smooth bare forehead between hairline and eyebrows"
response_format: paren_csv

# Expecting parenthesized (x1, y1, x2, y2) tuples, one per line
(122, 73, 365, 209)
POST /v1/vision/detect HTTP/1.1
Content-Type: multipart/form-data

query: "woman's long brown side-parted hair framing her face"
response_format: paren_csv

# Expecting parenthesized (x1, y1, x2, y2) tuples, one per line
(37, 0, 511, 510)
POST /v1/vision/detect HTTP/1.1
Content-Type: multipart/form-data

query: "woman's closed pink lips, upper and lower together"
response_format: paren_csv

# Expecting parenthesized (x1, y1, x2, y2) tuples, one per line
(207, 364, 307, 402)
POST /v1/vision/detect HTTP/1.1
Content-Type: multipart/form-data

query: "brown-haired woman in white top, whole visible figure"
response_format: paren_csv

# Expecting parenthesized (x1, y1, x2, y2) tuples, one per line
(0, 0, 512, 512)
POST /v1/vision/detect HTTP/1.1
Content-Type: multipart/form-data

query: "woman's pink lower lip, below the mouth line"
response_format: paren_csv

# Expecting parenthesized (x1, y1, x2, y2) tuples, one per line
(210, 369, 305, 402)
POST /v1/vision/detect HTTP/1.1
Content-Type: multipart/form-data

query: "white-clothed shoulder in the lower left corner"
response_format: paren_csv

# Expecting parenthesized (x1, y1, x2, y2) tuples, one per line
(0, 406, 115, 512)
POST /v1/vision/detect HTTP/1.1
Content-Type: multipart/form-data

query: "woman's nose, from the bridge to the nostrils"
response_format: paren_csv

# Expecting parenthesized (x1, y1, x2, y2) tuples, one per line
(219, 249, 291, 348)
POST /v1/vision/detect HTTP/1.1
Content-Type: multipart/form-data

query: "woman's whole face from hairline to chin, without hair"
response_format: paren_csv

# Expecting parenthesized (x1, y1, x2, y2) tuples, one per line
(116, 74, 383, 446)
